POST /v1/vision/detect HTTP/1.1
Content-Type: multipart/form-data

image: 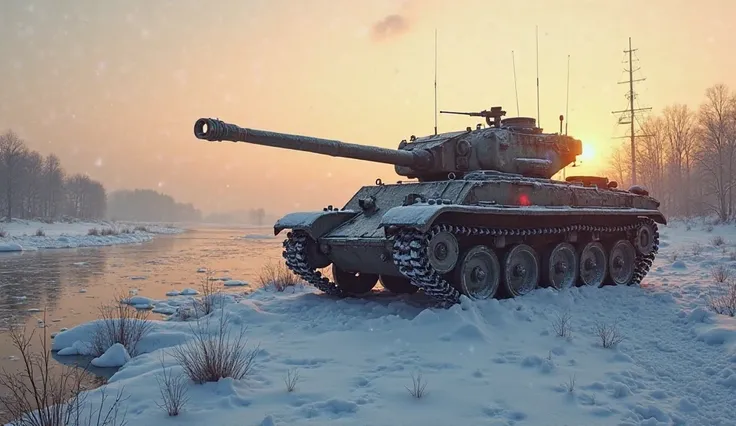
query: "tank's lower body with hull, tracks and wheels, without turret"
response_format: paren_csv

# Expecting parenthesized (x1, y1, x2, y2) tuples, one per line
(274, 172, 666, 303)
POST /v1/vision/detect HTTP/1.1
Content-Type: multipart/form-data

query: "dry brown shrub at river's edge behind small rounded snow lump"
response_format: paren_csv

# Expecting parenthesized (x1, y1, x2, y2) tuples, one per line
(92, 296, 153, 356)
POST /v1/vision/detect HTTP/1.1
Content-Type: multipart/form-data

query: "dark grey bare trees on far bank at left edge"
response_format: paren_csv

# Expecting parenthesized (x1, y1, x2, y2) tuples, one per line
(0, 130, 106, 221)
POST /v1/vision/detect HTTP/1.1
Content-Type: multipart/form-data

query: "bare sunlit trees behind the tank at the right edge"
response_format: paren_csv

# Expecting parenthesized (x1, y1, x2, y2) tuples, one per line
(608, 84, 736, 222)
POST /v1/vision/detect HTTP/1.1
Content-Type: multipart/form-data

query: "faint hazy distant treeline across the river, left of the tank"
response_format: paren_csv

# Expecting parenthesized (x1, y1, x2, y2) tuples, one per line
(107, 189, 202, 222)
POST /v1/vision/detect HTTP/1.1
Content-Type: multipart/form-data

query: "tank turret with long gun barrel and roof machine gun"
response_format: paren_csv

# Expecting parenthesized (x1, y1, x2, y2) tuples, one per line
(194, 107, 582, 181)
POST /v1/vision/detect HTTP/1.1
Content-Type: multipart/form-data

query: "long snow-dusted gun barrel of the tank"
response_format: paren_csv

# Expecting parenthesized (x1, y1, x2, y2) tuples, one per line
(194, 118, 432, 169)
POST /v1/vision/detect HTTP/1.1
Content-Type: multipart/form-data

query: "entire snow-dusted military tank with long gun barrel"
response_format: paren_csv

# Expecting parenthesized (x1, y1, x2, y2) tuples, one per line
(194, 107, 666, 304)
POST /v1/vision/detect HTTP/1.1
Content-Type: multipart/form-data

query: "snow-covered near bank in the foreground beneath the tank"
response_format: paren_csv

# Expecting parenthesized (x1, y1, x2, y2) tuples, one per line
(46, 223, 736, 426)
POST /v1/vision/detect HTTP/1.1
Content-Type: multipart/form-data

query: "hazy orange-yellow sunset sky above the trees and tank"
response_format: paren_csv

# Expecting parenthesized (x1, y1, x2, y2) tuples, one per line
(0, 0, 736, 213)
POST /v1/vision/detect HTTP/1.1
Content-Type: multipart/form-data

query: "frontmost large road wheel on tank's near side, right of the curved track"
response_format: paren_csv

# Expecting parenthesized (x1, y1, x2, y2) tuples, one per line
(456, 245, 501, 300)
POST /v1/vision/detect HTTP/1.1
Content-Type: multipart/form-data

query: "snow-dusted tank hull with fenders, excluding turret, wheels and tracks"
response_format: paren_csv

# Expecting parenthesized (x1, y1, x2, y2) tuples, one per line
(274, 173, 666, 300)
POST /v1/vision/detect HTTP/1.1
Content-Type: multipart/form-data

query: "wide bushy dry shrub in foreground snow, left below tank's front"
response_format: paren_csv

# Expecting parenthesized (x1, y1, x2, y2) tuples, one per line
(172, 310, 259, 384)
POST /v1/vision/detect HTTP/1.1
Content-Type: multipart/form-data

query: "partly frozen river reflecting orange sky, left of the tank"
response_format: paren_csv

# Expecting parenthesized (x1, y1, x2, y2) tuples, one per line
(0, 227, 283, 378)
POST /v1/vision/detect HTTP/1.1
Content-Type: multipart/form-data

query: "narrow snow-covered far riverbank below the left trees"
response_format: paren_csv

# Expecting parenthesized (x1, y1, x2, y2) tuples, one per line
(0, 219, 183, 252)
